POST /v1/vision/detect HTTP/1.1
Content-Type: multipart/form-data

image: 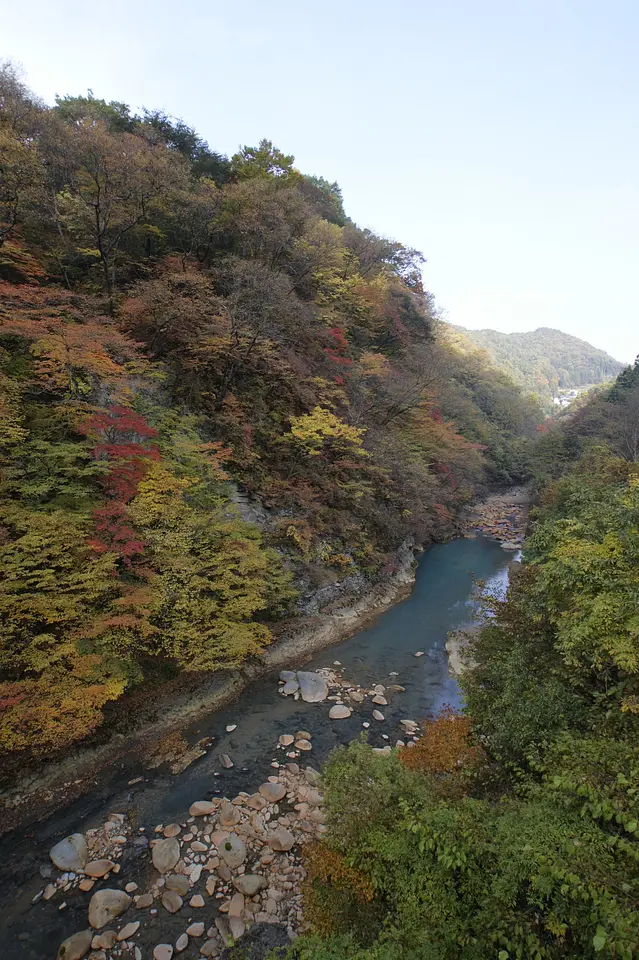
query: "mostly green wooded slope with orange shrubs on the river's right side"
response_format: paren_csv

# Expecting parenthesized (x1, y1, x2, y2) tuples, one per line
(292, 364, 639, 960)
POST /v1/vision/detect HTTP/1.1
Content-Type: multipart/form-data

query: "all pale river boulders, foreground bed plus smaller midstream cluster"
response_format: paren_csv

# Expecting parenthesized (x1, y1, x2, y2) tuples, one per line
(16, 668, 422, 960)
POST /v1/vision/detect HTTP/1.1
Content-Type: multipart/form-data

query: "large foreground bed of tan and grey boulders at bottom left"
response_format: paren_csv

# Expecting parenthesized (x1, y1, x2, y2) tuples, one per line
(46, 756, 325, 960)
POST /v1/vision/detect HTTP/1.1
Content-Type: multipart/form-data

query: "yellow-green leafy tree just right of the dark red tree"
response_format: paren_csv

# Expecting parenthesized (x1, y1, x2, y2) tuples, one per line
(131, 463, 296, 670)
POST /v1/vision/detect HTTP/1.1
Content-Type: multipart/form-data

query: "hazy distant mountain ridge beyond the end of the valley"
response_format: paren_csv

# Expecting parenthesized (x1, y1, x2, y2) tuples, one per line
(451, 324, 624, 402)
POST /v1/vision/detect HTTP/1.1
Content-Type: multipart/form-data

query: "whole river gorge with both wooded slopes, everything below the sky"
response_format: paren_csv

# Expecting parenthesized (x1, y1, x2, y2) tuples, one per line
(0, 64, 639, 960)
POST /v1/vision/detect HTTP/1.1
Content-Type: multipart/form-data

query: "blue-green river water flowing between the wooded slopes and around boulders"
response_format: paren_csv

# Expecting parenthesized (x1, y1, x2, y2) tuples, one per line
(0, 537, 513, 960)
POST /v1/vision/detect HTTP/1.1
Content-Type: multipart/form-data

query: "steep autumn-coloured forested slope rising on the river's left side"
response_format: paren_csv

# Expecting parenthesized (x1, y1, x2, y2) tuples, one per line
(0, 67, 540, 772)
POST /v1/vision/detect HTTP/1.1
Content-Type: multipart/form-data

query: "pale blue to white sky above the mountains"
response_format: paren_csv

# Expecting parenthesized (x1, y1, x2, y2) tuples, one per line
(0, 0, 639, 361)
